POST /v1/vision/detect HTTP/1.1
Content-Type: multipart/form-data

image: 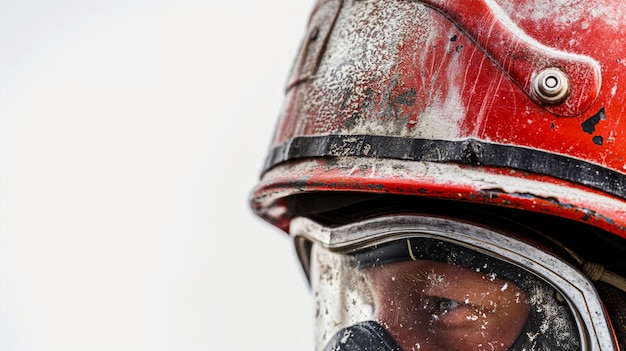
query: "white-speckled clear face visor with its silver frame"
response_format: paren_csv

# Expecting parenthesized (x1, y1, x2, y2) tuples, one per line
(291, 216, 615, 351)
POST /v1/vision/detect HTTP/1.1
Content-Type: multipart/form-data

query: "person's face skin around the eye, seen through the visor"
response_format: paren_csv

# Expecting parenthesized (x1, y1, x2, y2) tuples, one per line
(364, 260, 529, 351)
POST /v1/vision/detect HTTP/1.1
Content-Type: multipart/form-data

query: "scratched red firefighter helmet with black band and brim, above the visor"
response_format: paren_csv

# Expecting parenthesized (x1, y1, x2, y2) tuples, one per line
(251, 0, 626, 350)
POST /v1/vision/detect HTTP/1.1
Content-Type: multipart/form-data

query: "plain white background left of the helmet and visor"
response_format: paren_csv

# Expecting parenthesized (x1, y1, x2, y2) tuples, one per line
(0, 0, 313, 351)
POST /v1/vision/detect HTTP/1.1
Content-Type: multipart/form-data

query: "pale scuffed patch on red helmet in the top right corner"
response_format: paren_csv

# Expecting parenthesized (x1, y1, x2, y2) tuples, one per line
(498, 0, 626, 26)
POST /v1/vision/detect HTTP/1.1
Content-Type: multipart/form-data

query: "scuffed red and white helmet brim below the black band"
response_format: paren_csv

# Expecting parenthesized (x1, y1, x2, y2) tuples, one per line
(250, 157, 626, 238)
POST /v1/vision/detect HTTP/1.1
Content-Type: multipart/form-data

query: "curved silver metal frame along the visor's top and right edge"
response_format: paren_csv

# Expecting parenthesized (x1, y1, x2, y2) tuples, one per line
(290, 215, 617, 351)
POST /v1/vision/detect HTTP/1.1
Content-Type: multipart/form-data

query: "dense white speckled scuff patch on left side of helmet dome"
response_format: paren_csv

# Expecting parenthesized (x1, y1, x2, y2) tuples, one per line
(303, 1, 433, 134)
